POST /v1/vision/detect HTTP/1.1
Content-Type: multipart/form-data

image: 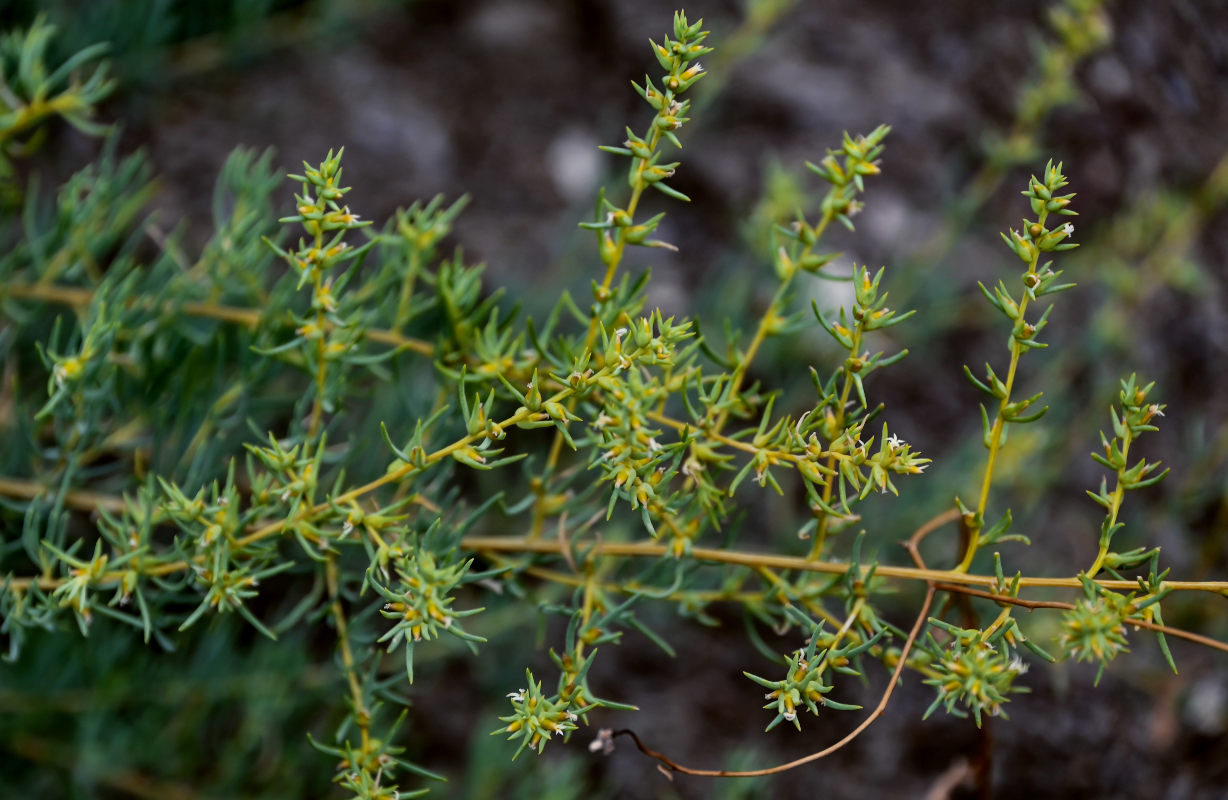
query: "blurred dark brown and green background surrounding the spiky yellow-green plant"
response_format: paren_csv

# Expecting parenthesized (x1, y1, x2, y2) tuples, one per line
(0, 0, 1228, 800)
